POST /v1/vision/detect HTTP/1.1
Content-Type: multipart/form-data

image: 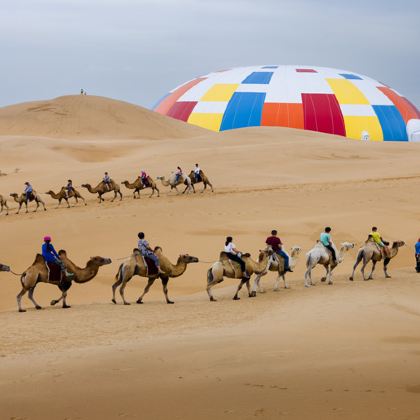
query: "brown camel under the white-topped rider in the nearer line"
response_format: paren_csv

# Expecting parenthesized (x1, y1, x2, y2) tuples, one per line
(207, 249, 273, 302)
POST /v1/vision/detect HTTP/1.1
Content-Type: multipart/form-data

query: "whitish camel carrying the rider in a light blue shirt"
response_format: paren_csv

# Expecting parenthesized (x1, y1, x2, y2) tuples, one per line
(305, 242, 354, 287)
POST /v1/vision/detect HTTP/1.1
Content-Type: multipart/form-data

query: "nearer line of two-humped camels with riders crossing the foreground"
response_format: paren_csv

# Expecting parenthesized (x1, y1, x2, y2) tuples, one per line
(0, 227, 408, 312)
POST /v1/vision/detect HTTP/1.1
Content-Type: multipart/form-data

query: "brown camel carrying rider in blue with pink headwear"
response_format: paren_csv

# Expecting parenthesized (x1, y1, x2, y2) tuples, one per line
(17, 250, 111, 312)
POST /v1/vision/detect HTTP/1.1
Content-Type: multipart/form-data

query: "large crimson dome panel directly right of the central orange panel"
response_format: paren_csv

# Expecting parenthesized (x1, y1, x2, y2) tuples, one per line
(302, 93, 346, 136)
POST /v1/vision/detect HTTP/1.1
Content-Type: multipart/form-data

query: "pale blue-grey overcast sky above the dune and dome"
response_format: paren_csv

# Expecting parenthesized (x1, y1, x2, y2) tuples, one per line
(0, 0, 420, 108)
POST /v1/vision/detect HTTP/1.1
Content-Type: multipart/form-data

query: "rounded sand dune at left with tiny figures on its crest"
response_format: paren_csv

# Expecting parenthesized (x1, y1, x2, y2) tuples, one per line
(0, 95, 206, 139)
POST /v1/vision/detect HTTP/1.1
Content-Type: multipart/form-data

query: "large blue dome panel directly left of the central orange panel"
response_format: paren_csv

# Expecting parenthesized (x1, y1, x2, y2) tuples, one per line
(220, 92, 265, 131)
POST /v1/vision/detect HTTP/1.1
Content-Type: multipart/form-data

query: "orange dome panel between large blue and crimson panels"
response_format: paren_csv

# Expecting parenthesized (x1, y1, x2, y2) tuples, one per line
(261, 102, 304, 128)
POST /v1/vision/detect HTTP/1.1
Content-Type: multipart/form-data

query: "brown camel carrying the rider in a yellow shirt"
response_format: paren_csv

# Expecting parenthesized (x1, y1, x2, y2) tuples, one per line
(349, 237, 405, 281)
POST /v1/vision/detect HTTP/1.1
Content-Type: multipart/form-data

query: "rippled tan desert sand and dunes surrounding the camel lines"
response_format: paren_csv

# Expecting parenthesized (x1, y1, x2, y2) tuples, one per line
(0, 96, 420, 420)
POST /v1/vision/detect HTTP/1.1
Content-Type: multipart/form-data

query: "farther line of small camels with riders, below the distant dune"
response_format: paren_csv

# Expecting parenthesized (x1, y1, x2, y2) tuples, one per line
(0, 164, 214, 216)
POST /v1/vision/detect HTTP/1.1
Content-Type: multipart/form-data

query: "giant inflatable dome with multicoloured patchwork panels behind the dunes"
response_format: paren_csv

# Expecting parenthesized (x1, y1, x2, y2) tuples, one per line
(154, 65, 420, 141)
